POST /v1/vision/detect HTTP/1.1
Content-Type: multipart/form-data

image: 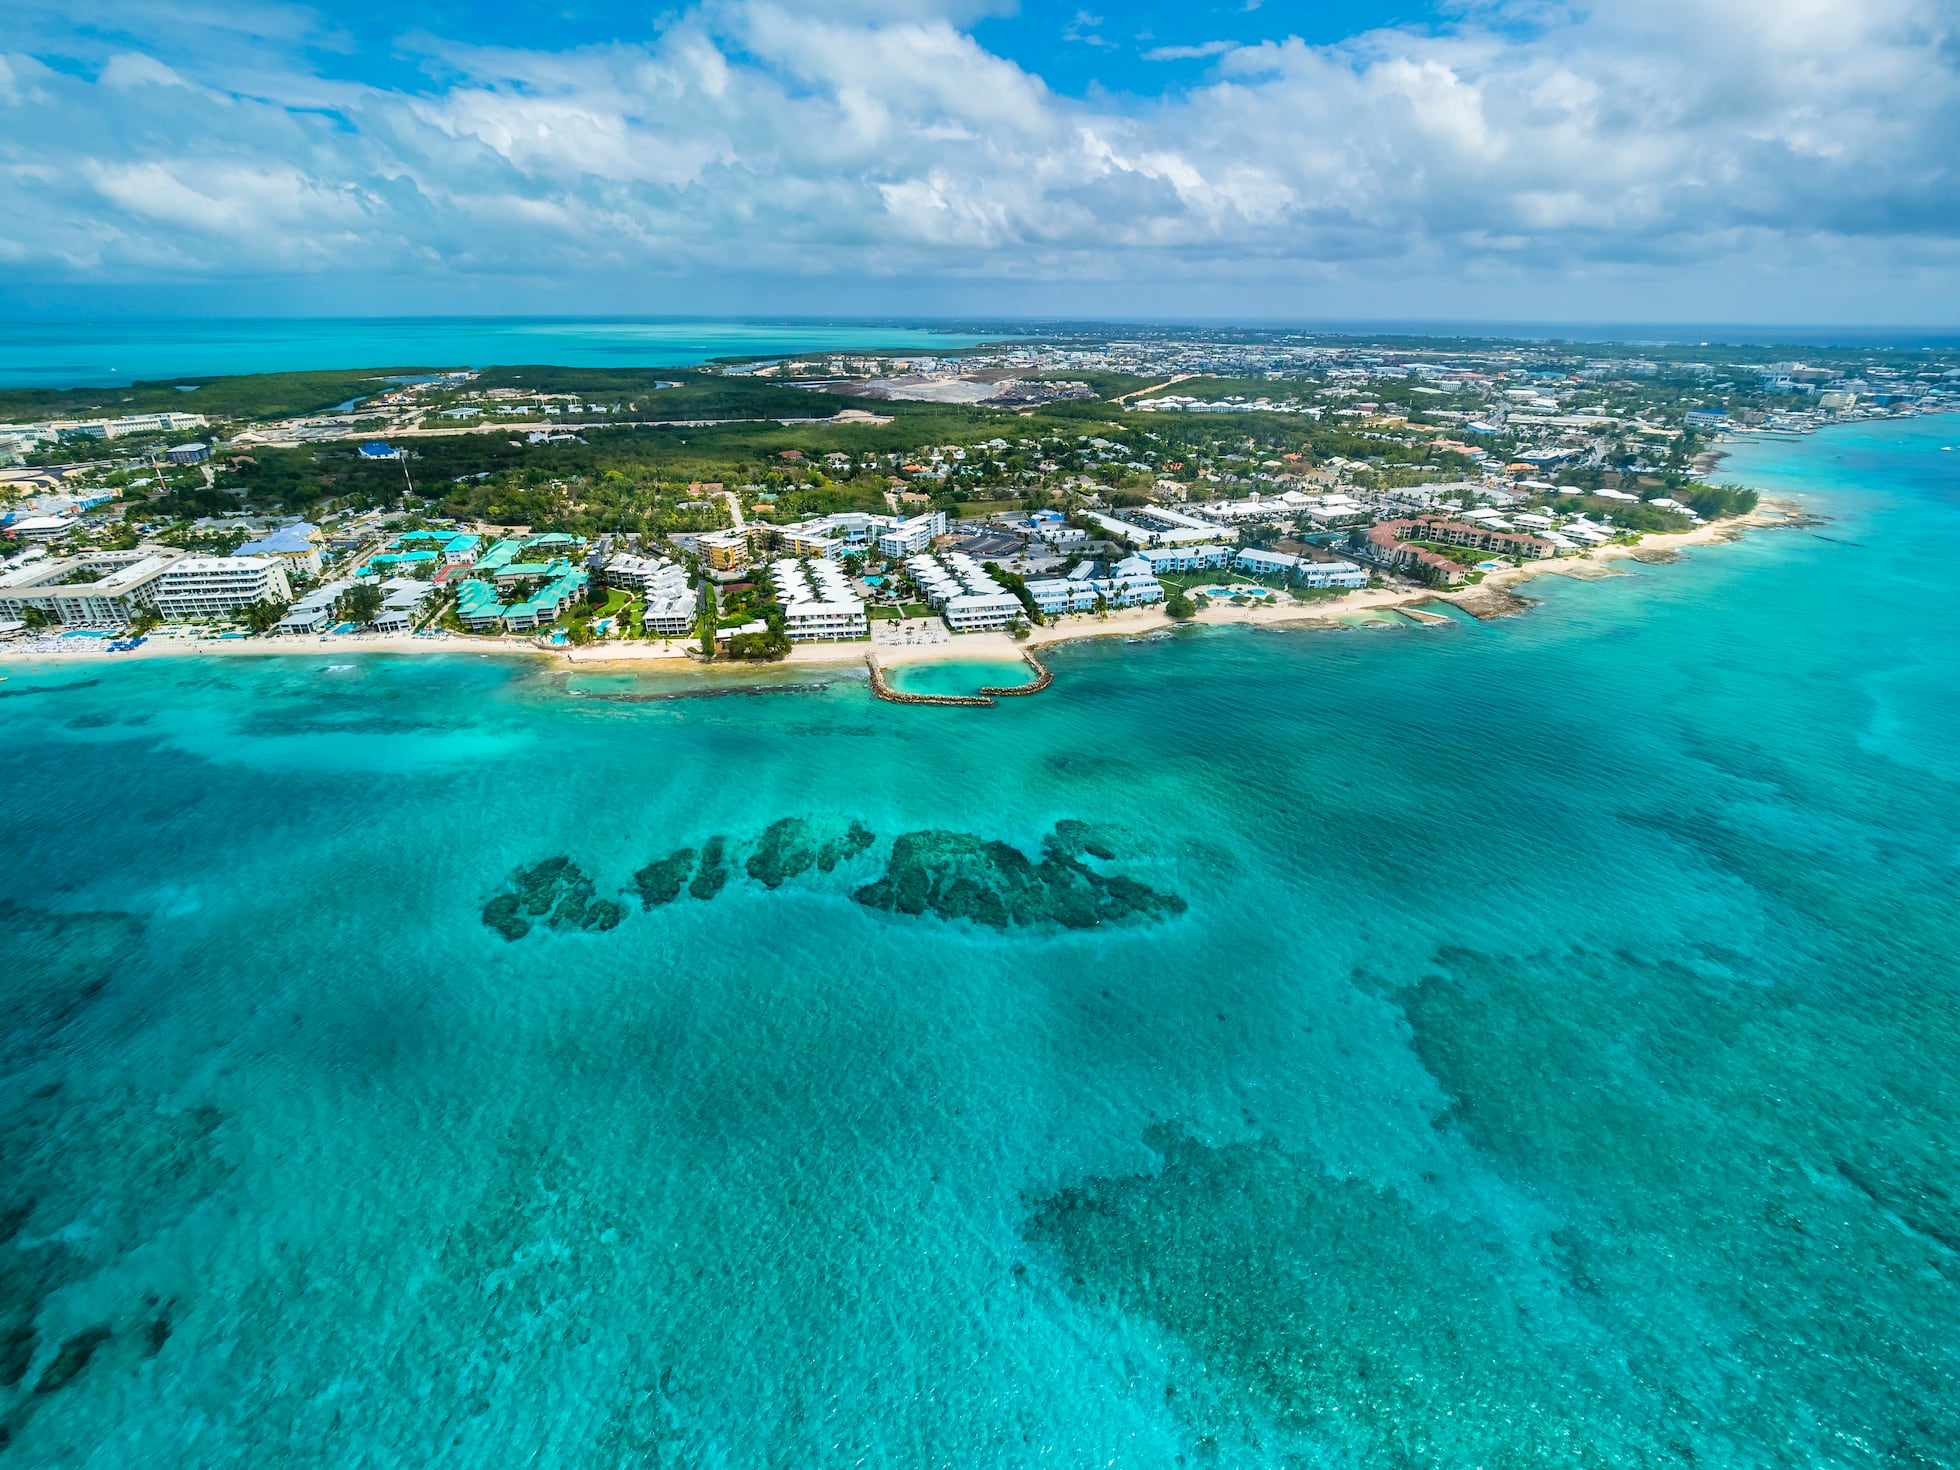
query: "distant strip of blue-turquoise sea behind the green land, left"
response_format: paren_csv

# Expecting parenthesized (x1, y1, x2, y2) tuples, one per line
(0, 318, 988, 388)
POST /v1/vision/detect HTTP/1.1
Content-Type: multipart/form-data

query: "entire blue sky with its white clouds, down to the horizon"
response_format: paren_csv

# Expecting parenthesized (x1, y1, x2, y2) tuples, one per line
(0, 0, 1960, 325)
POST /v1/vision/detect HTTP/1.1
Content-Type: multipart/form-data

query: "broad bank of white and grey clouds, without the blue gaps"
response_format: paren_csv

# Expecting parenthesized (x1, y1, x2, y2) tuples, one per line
(0, 0, 1960, 319)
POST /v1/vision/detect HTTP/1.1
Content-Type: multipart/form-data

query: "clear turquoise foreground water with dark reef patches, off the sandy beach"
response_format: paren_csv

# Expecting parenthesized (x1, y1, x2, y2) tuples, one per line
(0, 419, 1960, 1466)
